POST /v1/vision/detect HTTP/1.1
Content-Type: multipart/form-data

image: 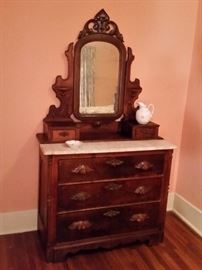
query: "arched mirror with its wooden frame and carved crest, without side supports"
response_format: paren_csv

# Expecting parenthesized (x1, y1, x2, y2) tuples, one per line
(73, 10, 127, 122)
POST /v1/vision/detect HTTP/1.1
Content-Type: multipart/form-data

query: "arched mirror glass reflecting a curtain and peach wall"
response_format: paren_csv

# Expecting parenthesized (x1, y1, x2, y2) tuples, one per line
(79, 41, 119, 114)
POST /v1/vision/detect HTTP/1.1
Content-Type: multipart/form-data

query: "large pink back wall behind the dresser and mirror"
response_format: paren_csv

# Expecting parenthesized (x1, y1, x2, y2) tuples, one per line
(0, 0, 198, 212)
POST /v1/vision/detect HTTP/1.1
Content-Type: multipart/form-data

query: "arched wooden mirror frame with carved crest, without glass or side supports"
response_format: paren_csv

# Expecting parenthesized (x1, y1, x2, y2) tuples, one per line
(74, 10, 126, 120)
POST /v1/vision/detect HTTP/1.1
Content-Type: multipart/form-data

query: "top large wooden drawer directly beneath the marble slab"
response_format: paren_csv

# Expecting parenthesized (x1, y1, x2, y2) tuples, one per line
(58, 151, 164, 183)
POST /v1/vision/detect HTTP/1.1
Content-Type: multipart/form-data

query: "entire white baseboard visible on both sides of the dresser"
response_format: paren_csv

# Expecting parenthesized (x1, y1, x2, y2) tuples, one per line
(0, 192, 202, 236)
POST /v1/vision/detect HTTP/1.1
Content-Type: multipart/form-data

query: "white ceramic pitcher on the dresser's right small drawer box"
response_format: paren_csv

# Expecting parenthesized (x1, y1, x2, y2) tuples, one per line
(134, 102, 154, 125)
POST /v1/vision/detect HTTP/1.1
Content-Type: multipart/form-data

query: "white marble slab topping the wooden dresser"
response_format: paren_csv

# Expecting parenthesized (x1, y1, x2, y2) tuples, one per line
(40, 140, 176, 155)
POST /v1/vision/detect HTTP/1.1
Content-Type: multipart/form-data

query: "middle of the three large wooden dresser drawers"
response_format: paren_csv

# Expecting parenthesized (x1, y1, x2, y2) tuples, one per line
(58, 178, 161, 211)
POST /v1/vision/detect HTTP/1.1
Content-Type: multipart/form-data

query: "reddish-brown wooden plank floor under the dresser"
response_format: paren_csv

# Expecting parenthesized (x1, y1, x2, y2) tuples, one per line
(0, 213, 202, 270)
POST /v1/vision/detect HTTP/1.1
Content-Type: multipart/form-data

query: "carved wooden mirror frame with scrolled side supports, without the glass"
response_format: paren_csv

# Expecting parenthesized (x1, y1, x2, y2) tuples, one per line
(44, 9, 142, 126)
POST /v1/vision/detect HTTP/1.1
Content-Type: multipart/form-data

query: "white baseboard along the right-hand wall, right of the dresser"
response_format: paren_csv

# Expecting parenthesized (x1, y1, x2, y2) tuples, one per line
(172, 193, 202, 237)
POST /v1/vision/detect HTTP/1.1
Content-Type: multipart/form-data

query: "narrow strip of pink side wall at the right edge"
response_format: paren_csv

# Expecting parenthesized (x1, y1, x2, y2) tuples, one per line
(176, 5, 202, 209)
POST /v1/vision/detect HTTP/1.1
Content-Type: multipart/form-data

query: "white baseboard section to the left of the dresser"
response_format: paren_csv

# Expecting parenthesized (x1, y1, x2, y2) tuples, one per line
(0, 209, 37, 235)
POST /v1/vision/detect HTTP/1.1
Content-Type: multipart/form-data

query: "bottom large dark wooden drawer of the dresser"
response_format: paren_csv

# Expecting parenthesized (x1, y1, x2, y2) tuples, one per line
(57, 203, 159, 242)
